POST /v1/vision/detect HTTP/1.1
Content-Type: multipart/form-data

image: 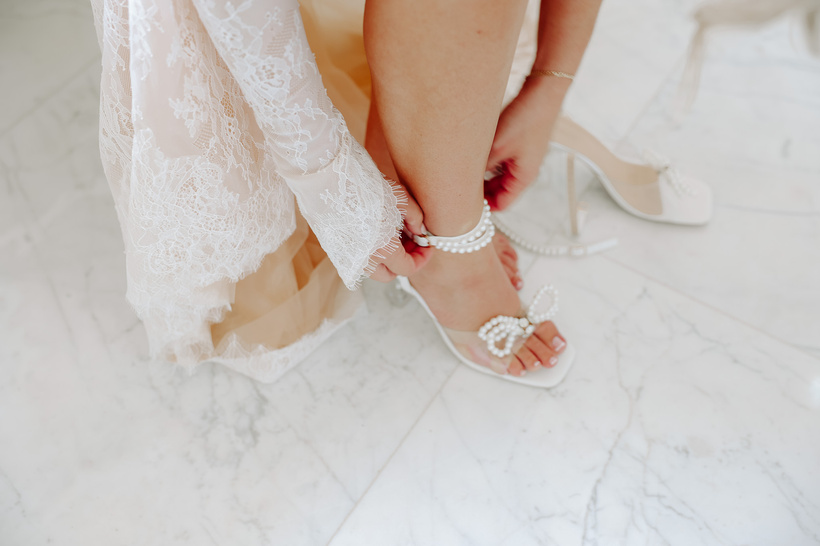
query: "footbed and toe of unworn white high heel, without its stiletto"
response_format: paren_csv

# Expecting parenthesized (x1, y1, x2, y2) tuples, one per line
(551, 116, 713, 225)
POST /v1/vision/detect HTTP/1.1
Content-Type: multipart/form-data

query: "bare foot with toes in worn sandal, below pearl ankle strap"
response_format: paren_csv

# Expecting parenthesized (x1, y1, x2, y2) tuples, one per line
(410, 247, 566, 376)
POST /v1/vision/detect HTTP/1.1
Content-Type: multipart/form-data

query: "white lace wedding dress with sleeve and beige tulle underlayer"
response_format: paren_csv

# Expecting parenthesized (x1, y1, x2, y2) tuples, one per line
(92, 0, 534, 381)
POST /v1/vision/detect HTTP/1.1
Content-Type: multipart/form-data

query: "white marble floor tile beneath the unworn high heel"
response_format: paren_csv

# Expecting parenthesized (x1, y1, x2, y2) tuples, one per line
(607, 14, 820, 355)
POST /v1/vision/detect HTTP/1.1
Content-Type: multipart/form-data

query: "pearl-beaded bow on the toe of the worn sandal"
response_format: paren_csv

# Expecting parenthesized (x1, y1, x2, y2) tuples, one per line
(478, 284, 558, 358)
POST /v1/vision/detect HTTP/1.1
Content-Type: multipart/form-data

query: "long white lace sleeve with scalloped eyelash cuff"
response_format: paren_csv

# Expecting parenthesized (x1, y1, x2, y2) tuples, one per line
(194, 0, 401, 288)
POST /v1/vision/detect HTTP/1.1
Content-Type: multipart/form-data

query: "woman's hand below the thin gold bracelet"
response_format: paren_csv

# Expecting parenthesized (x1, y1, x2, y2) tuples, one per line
(484, 77, 569, 210)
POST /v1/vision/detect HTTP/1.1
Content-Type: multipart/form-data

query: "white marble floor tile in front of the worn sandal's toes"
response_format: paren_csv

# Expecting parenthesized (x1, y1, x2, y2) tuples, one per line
(331, 257, 820, 546)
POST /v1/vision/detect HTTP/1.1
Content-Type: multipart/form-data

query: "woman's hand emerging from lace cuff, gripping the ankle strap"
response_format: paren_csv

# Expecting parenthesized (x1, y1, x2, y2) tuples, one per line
(370, 184, 433, 282)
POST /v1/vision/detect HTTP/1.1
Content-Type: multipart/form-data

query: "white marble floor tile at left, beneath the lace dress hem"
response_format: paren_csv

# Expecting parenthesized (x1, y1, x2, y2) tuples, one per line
(0, 54, 456, 545)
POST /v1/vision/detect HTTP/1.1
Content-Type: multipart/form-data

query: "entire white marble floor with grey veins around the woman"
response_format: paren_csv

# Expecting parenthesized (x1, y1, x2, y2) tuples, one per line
(0, 0, 820, 546)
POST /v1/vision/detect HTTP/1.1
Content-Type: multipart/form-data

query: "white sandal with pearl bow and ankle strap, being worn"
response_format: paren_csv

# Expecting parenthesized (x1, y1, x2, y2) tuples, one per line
(397, 201, 575, 388)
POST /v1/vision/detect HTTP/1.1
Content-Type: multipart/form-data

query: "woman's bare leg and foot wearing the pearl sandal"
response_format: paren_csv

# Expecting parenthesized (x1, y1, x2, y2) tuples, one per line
(364, 0, 563, 375)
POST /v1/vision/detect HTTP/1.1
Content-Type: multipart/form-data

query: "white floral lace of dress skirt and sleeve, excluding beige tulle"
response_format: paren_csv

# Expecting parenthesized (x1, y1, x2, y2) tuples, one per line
(92, 0, 401, 375)
